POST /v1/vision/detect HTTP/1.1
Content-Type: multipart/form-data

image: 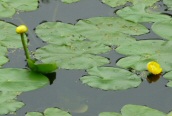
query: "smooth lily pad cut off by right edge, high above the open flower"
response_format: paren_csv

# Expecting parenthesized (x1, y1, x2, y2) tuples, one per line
(152, 20, 172, 40)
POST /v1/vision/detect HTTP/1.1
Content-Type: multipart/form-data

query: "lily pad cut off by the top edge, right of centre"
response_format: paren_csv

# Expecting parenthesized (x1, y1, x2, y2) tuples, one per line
(102, 0, 159, 7)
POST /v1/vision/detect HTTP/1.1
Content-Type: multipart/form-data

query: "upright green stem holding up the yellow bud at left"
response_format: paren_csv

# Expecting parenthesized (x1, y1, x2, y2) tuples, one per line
(20, 33, 30, 59)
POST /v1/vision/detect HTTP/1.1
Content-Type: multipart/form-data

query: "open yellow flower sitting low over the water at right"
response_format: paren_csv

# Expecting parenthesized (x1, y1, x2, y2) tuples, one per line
(147, 61, 162, 75)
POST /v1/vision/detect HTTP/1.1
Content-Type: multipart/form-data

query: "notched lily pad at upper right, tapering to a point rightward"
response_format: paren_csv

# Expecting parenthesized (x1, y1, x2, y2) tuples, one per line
(117, 4, 171, 23)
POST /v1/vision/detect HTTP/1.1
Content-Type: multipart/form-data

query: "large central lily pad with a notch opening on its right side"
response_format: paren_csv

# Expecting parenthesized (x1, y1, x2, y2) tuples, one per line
(35, 41, 111, 69)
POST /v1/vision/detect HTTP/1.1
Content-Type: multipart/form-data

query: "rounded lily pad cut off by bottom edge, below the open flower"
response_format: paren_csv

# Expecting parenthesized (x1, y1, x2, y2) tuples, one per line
(121, 104, 166, 116)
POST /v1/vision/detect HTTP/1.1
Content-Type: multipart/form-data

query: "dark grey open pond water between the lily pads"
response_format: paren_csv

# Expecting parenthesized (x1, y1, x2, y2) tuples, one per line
(4, 0, 172, 116)
